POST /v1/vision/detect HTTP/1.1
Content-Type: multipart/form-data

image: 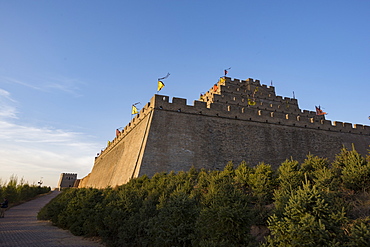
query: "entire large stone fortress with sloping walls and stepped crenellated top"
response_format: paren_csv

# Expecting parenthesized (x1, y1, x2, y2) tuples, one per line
(79, 77, 370, 188)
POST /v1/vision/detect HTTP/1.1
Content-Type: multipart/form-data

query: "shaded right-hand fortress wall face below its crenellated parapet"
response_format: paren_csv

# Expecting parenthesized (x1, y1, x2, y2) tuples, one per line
(139, 105, 370, 176)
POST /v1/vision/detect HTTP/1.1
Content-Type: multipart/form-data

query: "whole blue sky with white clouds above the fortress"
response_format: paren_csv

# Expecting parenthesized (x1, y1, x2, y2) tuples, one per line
(0, 0, 370, 187)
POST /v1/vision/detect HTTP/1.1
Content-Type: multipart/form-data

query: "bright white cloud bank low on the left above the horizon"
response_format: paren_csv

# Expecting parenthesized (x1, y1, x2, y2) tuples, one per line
(0, 89, 99, 187)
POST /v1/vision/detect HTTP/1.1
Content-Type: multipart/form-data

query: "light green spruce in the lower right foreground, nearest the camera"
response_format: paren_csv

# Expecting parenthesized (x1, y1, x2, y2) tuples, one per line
(265, 181, 346, 247)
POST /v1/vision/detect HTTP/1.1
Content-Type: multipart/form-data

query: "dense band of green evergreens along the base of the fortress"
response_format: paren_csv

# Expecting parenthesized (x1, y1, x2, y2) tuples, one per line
(38, 149, 370, 247)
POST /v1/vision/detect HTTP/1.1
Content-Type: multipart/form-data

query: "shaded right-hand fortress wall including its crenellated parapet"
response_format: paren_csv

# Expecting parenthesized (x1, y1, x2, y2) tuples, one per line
(134, 95, 370, 176)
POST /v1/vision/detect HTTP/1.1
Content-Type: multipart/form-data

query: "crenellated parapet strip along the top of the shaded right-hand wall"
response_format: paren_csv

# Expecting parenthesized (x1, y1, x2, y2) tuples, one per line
(151, 95, 370, 135)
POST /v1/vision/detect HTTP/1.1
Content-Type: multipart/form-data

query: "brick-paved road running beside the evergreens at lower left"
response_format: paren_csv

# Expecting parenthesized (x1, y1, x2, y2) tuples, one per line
(0, 191, 103, 247)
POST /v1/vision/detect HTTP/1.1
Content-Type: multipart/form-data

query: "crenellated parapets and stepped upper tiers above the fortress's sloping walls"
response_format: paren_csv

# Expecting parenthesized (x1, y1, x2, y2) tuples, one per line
(96, 77, 370, 161)
